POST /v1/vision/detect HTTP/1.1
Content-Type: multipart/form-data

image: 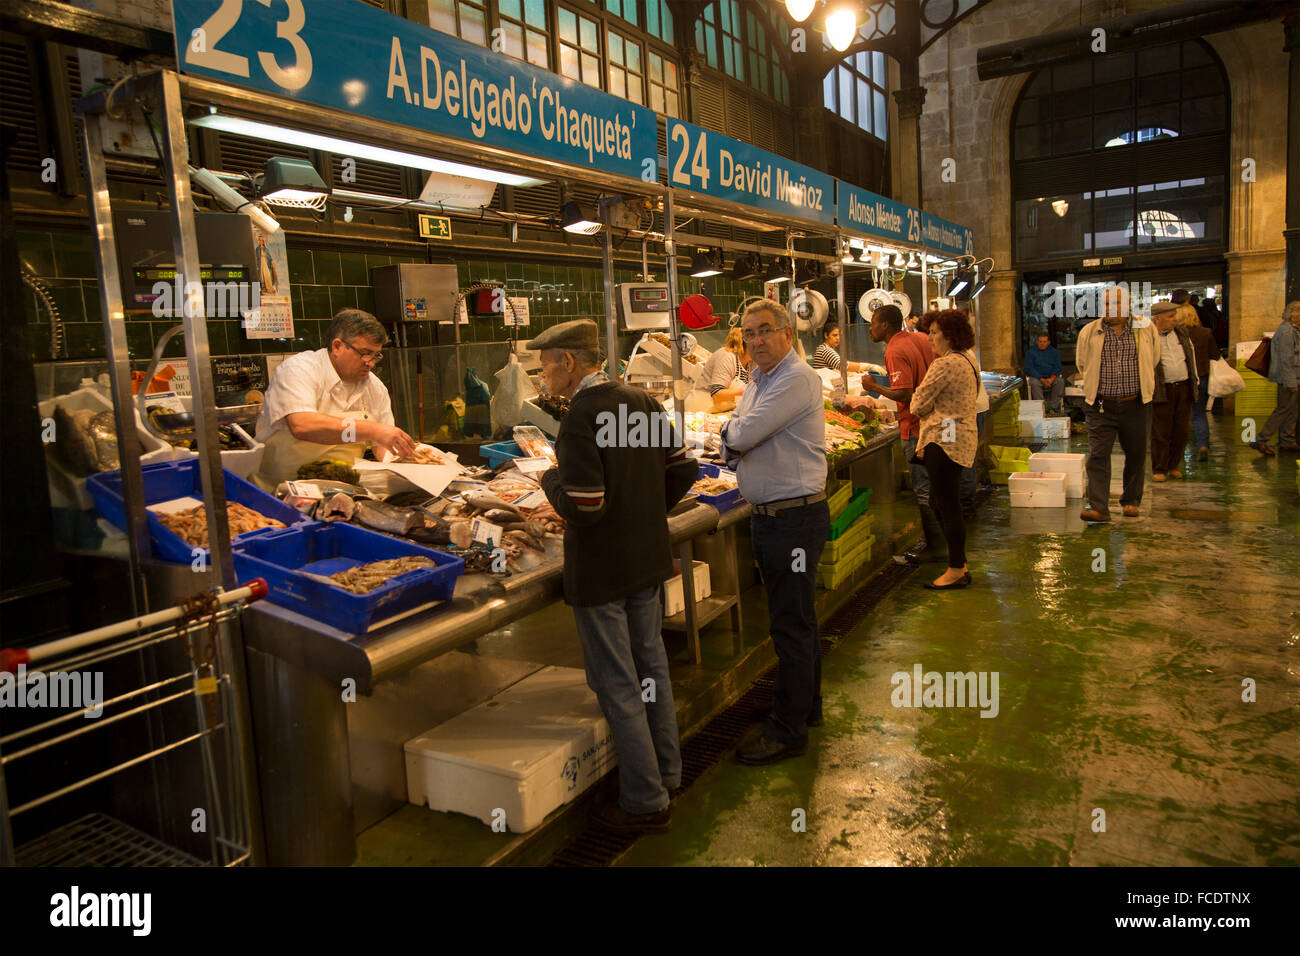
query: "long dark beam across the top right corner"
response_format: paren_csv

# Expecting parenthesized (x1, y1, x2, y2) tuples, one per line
(976, 0, 1300, 79)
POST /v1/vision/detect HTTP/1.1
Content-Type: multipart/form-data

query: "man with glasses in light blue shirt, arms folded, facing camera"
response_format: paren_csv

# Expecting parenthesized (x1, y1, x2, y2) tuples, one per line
(722, 300, 831, 766)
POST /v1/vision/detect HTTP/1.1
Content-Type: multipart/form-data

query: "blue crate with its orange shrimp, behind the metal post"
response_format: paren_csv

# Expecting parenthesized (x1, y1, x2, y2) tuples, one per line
(86, 458, 311, 564)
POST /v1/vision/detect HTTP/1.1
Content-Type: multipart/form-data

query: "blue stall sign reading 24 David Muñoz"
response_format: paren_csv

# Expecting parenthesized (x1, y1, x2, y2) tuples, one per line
(668, 118, 835, 225)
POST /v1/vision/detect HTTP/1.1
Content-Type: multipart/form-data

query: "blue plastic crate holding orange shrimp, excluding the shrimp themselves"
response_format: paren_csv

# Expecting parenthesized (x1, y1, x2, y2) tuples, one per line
(86, 458, 311, 564)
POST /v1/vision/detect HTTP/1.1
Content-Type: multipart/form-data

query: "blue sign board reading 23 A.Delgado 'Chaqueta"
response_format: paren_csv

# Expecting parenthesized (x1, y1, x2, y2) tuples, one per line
(172, 0, 659, 183)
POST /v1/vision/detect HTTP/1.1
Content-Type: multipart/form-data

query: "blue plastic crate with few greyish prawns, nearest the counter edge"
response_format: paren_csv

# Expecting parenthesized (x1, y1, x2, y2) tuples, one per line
(234, 522, 465, 633)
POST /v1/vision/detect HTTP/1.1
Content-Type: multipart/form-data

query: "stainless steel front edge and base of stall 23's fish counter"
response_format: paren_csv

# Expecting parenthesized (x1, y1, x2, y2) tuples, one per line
(244, 502, 722, 865)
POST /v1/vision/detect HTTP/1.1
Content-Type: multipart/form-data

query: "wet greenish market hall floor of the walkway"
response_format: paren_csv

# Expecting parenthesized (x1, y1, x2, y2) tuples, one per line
(613, 418, 1300, 866)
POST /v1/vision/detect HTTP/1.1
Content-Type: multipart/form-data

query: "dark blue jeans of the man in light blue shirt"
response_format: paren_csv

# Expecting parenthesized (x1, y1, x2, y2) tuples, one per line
(750, 501, 831, 747)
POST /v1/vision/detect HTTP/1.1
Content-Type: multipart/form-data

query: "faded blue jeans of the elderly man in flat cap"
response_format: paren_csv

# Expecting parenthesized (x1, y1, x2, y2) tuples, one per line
(573, 585, 681, 813)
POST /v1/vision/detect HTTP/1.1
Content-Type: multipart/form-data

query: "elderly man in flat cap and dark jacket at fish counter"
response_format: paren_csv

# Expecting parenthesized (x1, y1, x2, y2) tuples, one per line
(528, 319, 699, 832)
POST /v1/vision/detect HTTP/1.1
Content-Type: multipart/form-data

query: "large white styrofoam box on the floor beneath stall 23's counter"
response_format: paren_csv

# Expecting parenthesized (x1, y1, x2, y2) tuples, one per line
(404, 667, 616, 834)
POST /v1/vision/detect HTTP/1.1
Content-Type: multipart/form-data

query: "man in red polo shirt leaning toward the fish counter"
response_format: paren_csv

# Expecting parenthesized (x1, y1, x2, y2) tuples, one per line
(862, 306, 944, 564)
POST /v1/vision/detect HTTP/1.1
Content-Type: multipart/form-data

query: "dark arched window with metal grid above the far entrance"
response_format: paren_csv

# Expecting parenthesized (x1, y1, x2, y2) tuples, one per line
(1011, 40, 1229, 265)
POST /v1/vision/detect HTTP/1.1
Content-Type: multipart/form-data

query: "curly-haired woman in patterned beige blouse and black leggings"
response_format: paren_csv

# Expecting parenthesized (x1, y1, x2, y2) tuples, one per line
(911, 310, 980, 591)
